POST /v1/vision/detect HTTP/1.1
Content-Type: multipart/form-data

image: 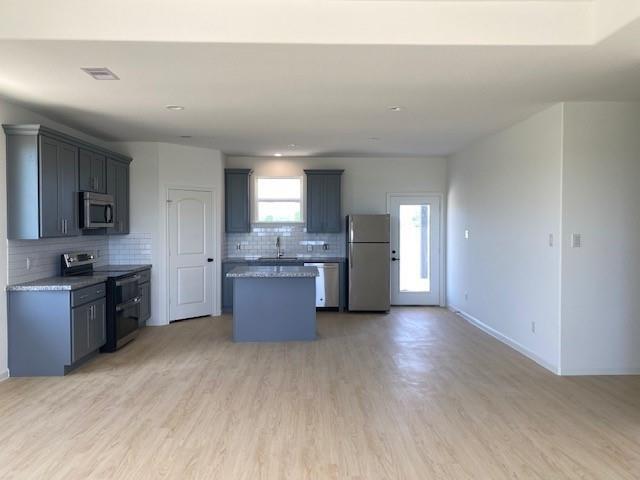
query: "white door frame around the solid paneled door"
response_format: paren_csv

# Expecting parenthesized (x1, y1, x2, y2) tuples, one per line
(162, 184, 222, 325)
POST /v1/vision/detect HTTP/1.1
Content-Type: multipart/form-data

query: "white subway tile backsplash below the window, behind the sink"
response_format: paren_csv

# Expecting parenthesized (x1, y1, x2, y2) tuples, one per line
(224, 224, 345, 257)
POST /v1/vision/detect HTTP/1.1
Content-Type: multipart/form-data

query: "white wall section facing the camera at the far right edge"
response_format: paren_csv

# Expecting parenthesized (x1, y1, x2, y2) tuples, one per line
(562, 103, 640, 374)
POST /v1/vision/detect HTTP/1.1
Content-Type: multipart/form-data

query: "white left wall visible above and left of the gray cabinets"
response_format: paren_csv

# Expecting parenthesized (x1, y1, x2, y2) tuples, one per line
(0, 99, 117, 379)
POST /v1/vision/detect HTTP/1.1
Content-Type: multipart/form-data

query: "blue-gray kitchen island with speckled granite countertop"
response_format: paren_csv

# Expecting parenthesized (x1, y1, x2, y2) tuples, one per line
(227, 266, 319, 342)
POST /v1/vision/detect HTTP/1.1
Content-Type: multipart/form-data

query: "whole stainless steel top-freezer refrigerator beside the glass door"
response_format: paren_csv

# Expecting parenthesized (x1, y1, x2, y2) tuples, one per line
(347, 215, 390, 312)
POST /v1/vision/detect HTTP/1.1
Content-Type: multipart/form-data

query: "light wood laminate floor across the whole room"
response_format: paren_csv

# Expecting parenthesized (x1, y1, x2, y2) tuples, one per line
(0, 308, 640, 480)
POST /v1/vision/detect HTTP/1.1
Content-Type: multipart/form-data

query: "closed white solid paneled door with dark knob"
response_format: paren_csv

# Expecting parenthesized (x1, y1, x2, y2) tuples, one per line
(168, 189, 214, 321)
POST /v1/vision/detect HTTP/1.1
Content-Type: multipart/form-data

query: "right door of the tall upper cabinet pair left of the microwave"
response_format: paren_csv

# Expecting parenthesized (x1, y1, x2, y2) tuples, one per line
(58, 143, 80, 237)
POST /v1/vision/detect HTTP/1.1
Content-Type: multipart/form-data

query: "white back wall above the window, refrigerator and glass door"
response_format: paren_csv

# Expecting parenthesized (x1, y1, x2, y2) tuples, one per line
(226, 157, 447, 215)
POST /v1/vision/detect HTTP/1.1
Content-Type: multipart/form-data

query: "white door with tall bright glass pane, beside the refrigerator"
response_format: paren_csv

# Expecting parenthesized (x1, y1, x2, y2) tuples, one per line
(389, 195, 441, 305)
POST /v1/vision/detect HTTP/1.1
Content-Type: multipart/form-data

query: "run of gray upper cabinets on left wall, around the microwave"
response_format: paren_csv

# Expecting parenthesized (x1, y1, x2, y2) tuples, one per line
(3, 125, 131, 240)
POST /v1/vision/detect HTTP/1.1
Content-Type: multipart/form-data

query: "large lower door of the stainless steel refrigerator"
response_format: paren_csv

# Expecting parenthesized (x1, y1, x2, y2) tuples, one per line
(347, 243, 390, 312)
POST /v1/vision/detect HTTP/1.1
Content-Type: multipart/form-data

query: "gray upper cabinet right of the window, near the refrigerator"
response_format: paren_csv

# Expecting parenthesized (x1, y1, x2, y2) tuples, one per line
(305, 170, 344, 233)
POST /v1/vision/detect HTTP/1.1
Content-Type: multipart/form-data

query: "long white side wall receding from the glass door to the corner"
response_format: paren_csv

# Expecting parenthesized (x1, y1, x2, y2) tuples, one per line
(447, 105, 563, 371)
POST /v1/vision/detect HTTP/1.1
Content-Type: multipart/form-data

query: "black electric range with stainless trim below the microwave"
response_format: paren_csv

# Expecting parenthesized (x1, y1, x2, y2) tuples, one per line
(60, 253, 148, 352)
